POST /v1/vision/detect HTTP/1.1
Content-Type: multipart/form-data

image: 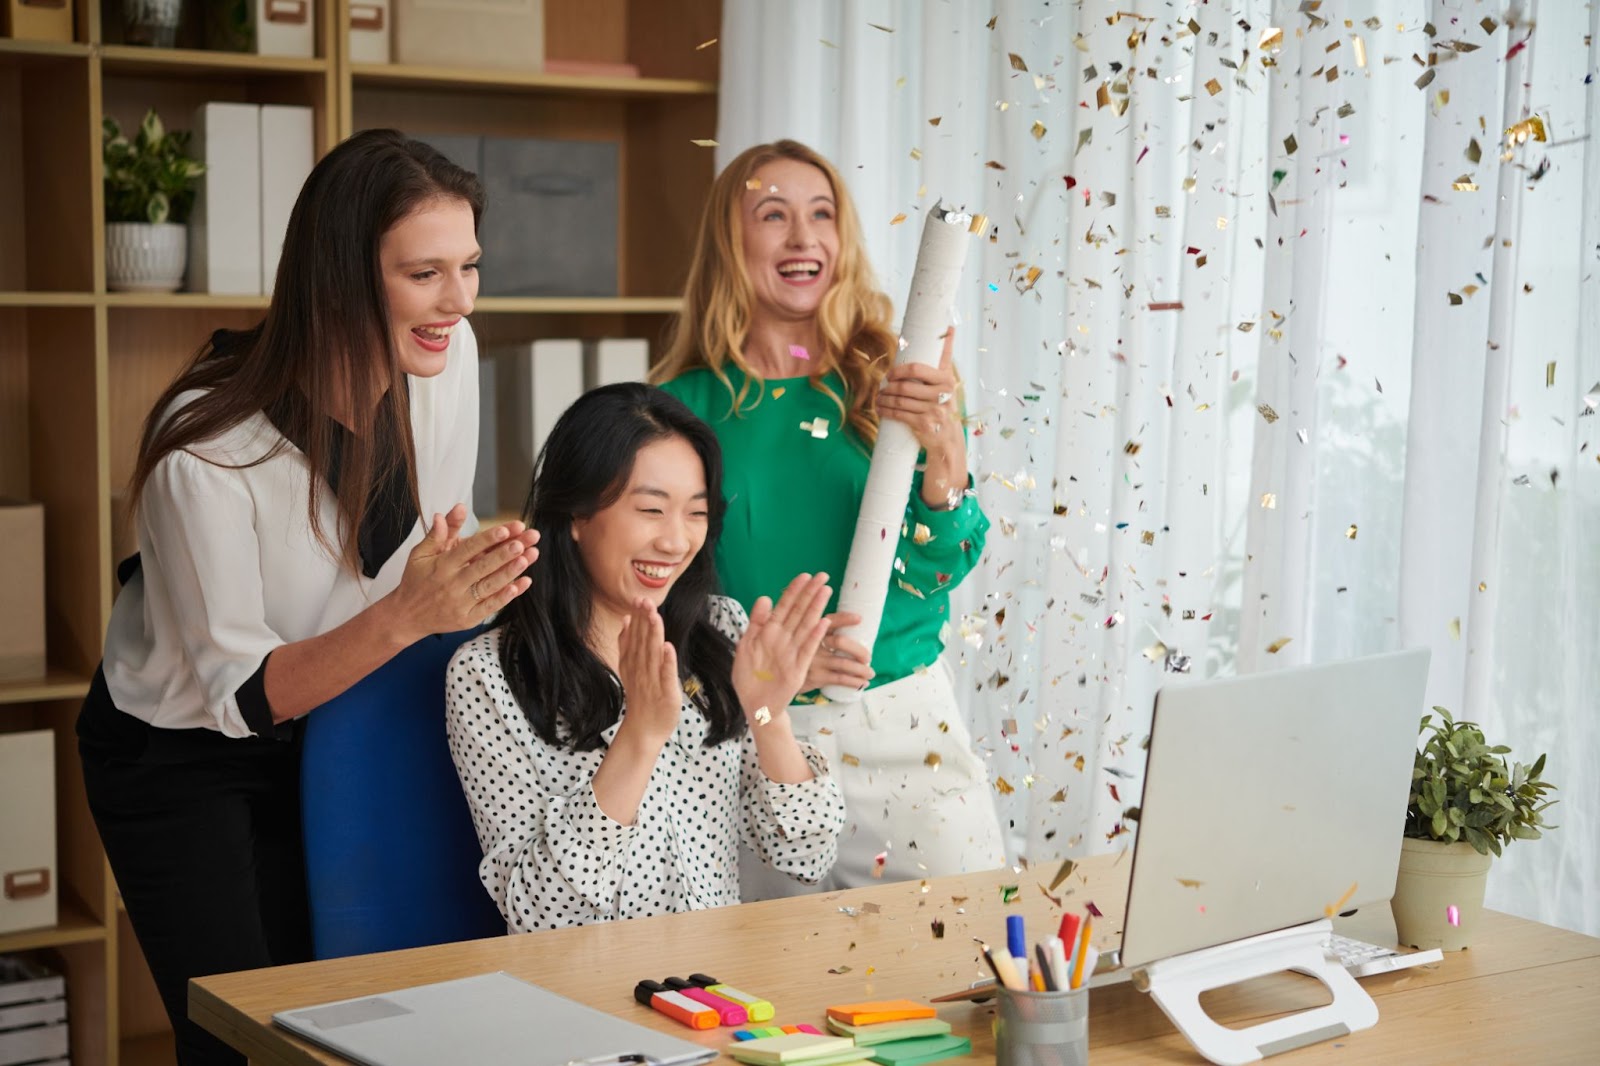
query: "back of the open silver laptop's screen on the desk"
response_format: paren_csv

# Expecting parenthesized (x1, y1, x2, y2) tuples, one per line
(1120, 648, 1429, 975)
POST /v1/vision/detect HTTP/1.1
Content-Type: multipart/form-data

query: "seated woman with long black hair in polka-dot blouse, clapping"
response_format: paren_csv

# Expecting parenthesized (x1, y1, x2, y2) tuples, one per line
(445, 384, 845, 930)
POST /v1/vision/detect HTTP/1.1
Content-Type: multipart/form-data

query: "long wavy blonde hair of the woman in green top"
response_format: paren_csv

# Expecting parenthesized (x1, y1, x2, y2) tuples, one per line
(650, 141, 896, 448)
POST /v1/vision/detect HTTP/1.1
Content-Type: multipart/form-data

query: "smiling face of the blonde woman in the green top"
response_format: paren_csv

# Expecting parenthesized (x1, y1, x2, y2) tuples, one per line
(739, 158, 838, 322)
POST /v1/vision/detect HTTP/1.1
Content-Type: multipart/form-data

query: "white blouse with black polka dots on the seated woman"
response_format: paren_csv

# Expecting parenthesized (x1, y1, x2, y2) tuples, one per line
(445, 598, 845, 932)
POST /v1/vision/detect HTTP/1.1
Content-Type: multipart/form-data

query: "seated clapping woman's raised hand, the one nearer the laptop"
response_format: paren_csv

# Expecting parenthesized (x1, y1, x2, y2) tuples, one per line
(733, 573, 832, 727)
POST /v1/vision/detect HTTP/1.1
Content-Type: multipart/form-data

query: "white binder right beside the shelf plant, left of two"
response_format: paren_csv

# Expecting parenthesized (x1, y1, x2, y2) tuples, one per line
(189, 102, 261, 296)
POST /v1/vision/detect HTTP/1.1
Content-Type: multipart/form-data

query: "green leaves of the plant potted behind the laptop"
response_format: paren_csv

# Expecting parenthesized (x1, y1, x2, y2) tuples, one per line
(1405, 707, 1555, 855)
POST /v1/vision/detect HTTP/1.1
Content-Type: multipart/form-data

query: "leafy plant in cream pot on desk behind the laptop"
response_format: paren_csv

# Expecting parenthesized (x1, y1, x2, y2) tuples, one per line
(1390, 707, 1555, 951)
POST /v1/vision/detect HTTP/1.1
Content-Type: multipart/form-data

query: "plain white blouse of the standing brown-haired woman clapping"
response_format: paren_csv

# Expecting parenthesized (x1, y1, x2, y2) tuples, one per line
(104, 322, 478, 738)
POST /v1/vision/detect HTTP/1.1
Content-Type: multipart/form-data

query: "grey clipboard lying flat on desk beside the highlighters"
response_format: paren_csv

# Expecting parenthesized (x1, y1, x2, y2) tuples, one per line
(272, 973, 717, 1066)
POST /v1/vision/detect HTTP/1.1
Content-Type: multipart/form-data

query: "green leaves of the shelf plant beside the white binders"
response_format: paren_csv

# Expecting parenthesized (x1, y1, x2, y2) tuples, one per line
(101, 110, 205, 224)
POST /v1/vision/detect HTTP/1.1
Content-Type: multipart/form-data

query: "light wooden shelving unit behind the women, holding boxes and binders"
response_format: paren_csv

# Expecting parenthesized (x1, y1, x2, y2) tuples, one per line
(0, 0, 722, 1066)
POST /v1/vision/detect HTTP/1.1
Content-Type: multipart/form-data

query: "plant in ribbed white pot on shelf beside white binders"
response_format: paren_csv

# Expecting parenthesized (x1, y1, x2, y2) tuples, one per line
(101, 110, 205, 293)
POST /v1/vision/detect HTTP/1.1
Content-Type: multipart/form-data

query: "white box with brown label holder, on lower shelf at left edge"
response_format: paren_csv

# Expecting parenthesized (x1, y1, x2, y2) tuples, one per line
(0, 730, 56, 928)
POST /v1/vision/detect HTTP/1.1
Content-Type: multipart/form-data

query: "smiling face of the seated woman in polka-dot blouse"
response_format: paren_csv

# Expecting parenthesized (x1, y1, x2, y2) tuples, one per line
(573, 437, 709, 621)
